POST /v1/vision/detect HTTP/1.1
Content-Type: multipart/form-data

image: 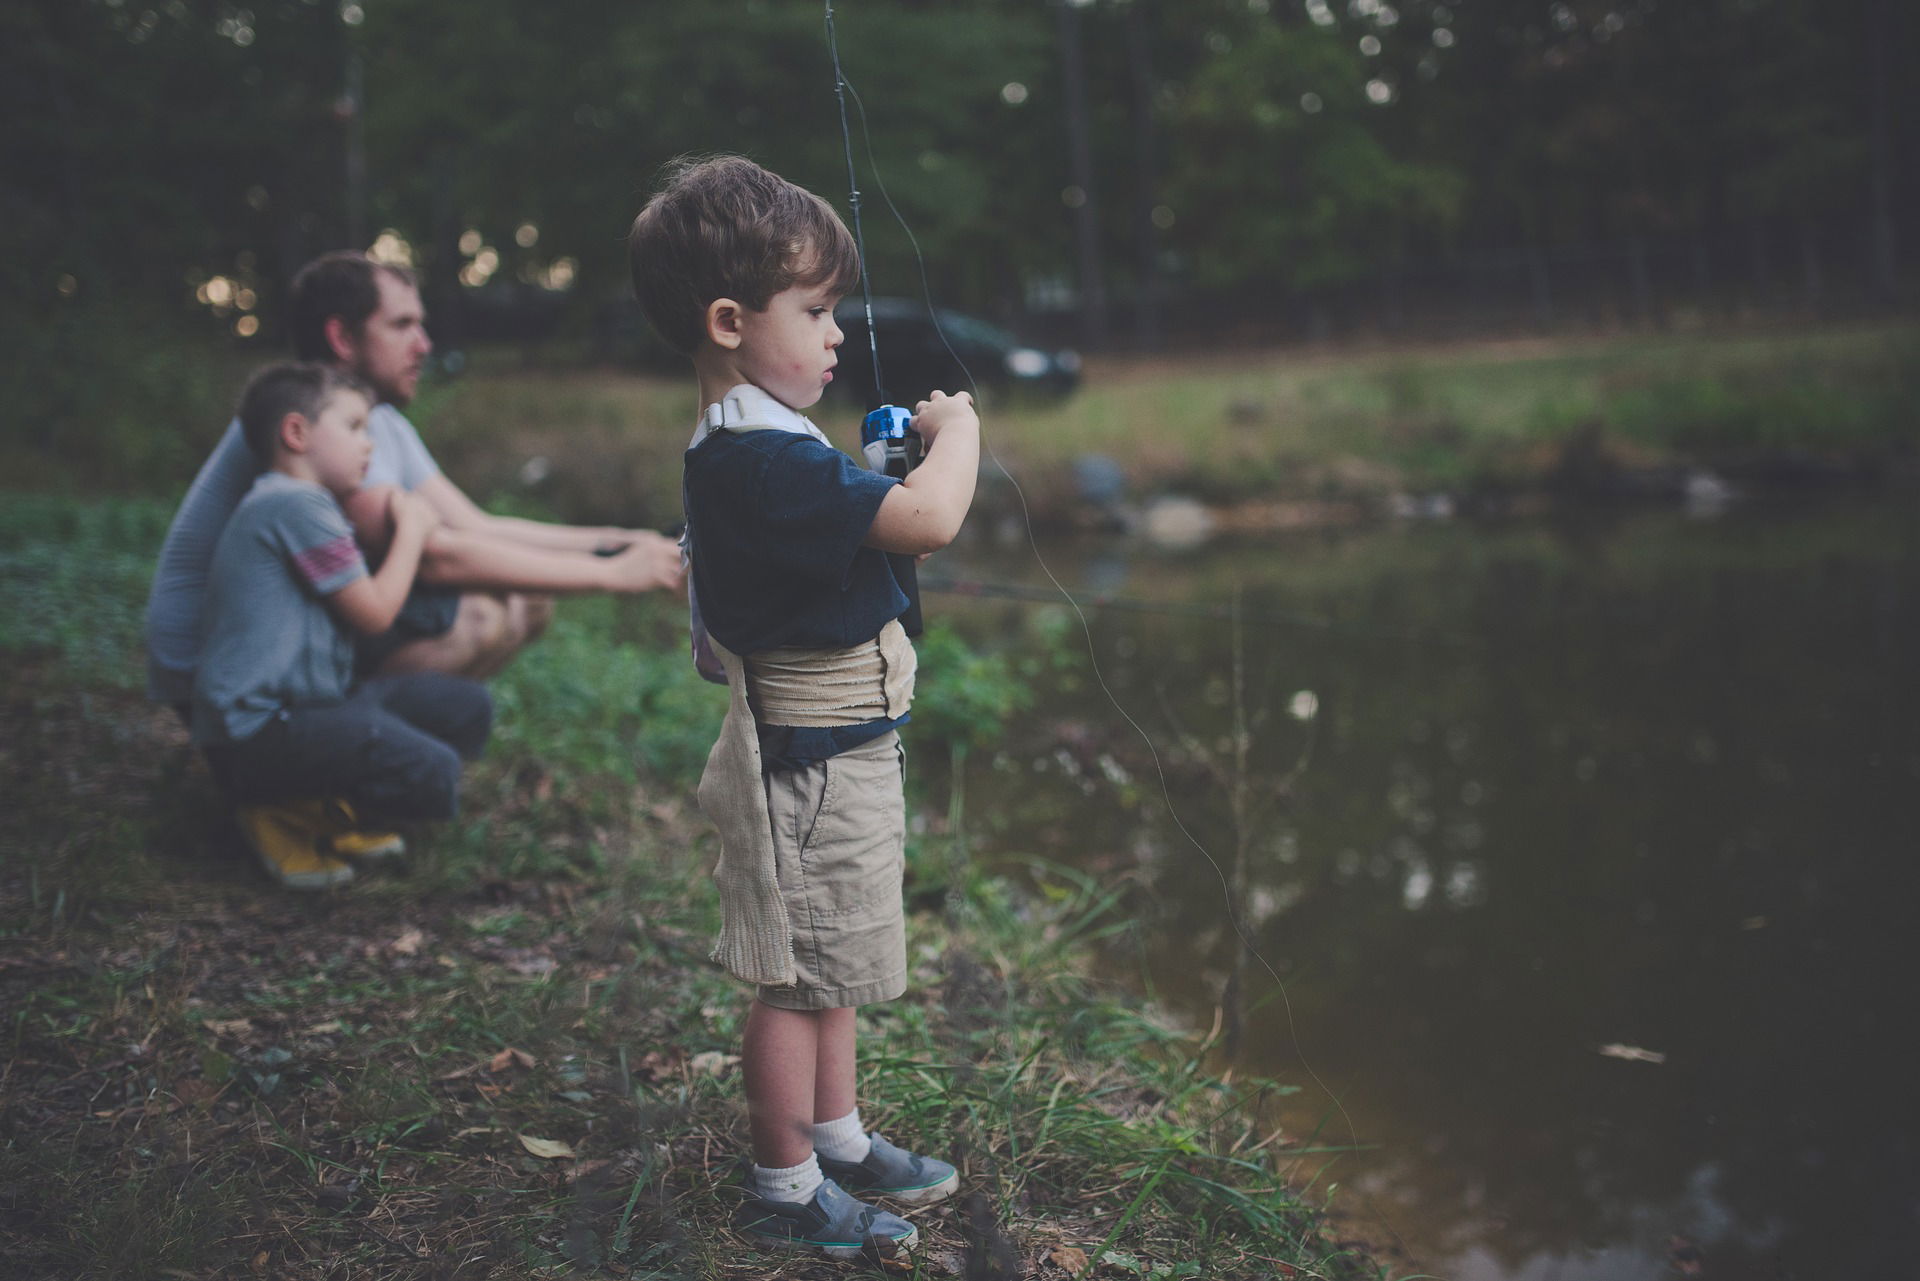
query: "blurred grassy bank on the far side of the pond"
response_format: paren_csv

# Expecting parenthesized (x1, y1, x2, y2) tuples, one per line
(408, 325, 1920, 520)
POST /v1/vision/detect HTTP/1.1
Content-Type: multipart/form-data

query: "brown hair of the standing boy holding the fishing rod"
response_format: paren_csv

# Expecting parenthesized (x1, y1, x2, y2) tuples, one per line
(626, 156, 860, 355)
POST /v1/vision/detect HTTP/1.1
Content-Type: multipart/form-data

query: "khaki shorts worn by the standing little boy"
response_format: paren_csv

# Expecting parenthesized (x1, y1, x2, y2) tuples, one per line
(758, 732, 906, 1010)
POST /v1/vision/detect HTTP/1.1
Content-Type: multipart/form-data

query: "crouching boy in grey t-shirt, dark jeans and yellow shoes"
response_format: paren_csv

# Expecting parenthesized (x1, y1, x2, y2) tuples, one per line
(192, 363, 493, 889)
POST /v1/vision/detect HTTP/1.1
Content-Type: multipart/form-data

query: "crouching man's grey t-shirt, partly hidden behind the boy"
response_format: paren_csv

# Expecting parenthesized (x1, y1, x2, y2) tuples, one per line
(146, 405, 440, 703)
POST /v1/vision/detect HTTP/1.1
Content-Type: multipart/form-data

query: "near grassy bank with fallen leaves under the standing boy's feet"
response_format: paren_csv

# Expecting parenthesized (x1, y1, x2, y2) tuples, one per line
(0, 495, 1375, 1277)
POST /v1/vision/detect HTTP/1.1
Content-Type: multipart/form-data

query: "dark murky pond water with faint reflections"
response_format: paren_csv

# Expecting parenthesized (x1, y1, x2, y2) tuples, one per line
(925, 501, 1920, 1281)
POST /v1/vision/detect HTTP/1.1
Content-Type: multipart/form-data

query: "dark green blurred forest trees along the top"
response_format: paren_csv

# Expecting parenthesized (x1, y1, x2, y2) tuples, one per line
(0, 0, 1920, 455)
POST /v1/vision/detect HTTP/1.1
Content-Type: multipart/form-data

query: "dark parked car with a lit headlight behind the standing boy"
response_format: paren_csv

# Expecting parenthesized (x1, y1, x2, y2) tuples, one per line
(833, 298, 1081, 409)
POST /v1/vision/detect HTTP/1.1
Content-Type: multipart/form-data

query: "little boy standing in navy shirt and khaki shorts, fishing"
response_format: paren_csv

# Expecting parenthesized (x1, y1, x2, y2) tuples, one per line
(630, 156, 979, 1258)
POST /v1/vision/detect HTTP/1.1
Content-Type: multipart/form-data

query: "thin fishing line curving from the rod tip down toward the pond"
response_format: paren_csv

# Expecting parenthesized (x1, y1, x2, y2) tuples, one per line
(826, 0, 1400, 1241)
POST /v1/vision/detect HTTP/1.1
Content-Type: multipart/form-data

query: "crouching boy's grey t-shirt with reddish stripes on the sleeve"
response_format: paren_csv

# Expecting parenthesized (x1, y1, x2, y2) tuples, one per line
(194, 471, 367, 747)
